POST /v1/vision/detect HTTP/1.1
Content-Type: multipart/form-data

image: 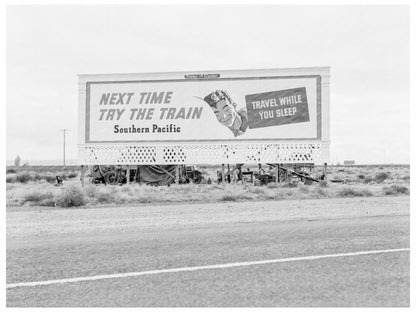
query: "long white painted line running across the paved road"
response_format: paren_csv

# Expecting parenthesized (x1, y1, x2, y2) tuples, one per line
(6, 248, 410, 289)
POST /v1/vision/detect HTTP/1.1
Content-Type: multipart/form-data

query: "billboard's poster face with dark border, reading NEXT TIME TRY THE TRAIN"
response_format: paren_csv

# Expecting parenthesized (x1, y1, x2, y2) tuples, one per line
(80, 74, 322, 143)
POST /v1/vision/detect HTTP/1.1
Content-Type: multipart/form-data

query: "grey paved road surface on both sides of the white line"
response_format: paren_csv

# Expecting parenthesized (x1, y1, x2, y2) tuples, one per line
(7, 199, 409, 307)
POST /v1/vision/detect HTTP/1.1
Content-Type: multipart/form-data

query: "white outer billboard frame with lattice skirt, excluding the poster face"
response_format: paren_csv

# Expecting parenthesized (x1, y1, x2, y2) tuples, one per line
(78, 67, 330, 164)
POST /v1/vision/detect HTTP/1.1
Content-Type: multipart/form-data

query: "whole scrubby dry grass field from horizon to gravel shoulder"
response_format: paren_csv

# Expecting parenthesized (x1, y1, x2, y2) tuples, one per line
(6, 167, 410, 207)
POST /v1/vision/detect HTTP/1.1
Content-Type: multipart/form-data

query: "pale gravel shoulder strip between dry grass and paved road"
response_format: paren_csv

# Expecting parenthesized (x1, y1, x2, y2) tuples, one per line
(6, 196, 410, 242)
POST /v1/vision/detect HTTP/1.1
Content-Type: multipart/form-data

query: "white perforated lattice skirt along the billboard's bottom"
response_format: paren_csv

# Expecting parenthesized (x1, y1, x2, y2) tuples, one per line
(79, 142, 329, 165)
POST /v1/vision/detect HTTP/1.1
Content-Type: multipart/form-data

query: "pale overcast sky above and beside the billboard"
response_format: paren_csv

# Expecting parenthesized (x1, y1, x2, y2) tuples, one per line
(6, 5, 409, 163)
